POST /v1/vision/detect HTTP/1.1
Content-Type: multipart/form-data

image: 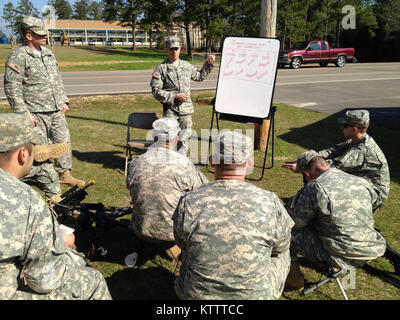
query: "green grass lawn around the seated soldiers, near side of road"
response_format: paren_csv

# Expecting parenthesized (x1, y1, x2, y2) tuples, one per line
(0, 91, 400, 300)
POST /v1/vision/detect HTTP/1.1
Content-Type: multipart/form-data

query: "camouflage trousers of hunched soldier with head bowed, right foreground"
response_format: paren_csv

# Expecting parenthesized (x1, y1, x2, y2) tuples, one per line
(290, 227, 367, 269)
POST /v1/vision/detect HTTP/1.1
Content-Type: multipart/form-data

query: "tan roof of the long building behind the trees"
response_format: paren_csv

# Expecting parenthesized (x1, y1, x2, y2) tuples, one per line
(48, 19, 132, 30)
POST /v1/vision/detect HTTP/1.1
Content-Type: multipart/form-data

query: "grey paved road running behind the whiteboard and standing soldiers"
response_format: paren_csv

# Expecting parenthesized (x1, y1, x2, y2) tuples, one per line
(0, 63, 400, 114)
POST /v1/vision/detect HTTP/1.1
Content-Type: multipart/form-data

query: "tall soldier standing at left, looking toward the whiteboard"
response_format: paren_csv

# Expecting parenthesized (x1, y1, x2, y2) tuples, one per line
(4, 16, 85, 186)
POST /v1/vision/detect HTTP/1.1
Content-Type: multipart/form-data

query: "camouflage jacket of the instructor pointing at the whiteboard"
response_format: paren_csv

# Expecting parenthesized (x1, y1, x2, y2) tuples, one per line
(150, 59, 214, 115)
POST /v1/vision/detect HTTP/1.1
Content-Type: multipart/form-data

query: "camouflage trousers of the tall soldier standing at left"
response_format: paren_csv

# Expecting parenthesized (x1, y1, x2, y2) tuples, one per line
(32, 110, 72, 174)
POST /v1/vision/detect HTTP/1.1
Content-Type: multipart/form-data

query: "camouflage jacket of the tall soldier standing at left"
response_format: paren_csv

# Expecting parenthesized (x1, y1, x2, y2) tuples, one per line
(4, 45, 69, 113)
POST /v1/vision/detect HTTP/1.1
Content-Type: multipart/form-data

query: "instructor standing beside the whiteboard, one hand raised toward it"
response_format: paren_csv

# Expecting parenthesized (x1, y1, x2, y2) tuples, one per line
(150, 36, 215, 155)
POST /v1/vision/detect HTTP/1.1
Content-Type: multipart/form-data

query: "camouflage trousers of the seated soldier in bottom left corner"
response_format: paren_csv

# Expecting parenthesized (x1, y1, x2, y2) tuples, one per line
(12, 267, 112, 300)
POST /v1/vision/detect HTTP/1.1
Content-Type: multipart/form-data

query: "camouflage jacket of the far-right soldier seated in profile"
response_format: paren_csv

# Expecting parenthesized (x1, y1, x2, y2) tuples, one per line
(318, 134, 390, 207)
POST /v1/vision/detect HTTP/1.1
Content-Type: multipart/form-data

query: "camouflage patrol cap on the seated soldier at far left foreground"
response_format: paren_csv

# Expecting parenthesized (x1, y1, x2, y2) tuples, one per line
(0, 113, 42, 152)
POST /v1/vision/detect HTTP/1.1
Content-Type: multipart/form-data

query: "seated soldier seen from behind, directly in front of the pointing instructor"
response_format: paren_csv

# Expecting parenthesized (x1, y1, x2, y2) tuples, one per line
(127, 118, 208, 258)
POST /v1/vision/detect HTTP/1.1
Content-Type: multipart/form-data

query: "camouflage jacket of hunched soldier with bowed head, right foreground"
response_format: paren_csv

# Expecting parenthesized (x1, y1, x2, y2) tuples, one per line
(288, 168, 386, 260)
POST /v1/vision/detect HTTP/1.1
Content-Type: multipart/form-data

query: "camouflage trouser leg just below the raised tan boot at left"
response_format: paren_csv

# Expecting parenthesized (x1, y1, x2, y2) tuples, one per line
(21, 160, 61, 198)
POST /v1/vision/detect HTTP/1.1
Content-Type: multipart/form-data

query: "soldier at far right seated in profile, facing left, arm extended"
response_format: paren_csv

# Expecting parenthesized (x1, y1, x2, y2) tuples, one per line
(283, 110, 390, 209)
